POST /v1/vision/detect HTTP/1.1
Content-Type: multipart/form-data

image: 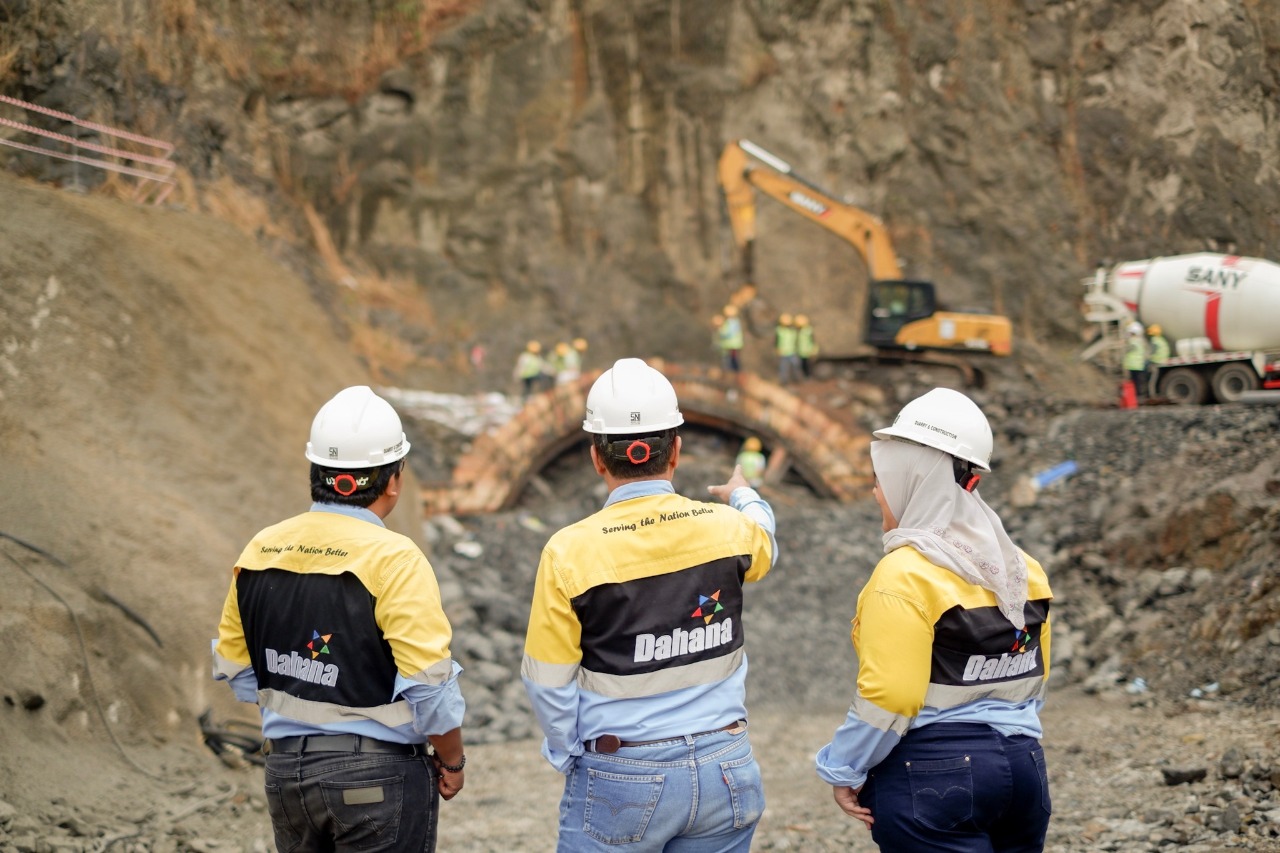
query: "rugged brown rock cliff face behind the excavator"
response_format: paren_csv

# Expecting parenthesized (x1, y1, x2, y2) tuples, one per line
(0, 0, 1280, 383)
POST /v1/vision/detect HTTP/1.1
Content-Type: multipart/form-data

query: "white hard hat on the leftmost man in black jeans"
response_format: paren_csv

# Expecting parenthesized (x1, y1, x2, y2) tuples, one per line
(307, 386, 408, 470)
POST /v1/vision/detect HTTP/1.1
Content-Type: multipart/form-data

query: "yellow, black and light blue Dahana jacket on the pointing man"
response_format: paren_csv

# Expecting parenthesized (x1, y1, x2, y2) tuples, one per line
(521, 480, 776, 772)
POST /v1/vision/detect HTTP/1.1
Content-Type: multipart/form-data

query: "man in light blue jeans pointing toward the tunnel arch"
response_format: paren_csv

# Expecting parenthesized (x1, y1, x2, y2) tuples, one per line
(521, 359, 777, 853)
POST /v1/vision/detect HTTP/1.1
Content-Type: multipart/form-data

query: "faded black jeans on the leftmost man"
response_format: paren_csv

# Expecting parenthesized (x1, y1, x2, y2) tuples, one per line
(266, 752, 440, 853)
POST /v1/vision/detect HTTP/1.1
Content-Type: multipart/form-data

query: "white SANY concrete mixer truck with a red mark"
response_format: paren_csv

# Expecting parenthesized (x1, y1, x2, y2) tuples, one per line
(1084, 252, 1280, 406)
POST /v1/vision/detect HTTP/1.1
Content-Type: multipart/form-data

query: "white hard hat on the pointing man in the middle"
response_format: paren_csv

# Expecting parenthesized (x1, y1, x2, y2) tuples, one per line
(582, 359, 685, 435)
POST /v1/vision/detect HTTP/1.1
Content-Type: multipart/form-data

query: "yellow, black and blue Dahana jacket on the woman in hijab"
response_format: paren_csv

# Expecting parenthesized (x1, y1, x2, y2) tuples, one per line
(817, 546, 1053, 788)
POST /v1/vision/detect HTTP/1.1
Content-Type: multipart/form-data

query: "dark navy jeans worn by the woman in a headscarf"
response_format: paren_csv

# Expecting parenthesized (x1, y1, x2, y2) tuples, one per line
(859, 722, 1052, 853)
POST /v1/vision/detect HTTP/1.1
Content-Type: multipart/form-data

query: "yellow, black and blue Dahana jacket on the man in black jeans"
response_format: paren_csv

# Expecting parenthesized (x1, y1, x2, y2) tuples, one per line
(214, 505, 465, 743)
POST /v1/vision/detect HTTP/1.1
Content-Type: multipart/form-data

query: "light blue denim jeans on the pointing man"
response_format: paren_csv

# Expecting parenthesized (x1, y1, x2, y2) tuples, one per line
(557, 731, 764, 853)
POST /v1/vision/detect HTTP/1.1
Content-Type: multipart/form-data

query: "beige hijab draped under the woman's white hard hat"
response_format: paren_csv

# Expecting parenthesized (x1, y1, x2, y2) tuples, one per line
(872, 441, 1027, 629)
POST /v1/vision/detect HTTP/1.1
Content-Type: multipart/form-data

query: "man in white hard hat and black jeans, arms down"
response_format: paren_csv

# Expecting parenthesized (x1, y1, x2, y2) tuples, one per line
(214, 386, 466, 850)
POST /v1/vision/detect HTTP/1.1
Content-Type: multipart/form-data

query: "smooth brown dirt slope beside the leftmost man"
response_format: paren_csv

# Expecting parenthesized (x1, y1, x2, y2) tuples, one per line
(0, 174, 430, 799)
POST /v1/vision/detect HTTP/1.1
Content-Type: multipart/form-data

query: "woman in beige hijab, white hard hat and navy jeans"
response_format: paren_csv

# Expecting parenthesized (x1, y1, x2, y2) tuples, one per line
(817, 388, 1052, 853)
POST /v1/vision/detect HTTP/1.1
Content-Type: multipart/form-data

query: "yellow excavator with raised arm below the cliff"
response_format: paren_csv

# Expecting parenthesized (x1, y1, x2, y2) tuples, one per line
(718, 140, 1012, 368)
